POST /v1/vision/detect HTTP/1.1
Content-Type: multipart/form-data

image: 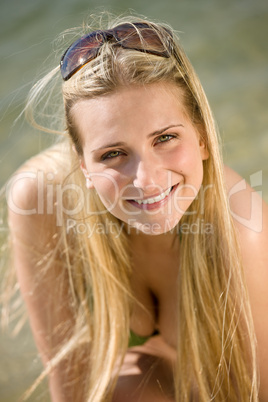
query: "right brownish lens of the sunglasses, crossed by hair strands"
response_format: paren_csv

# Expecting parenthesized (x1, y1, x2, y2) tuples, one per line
(115, 23, 169, 57)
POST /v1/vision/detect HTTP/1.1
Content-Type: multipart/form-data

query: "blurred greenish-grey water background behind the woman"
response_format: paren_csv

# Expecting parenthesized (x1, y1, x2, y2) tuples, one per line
(0, 0, 268, 402)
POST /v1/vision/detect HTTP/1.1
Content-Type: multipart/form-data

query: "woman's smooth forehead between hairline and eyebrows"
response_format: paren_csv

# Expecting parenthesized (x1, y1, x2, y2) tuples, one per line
(72, 83, 186, 142)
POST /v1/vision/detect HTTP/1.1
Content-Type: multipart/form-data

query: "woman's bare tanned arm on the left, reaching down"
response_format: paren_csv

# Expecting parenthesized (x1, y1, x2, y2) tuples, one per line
(9, 163, 88, 402)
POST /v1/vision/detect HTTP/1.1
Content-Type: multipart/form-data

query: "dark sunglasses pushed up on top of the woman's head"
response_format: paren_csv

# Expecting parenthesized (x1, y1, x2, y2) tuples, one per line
(60, 22, 172, 81)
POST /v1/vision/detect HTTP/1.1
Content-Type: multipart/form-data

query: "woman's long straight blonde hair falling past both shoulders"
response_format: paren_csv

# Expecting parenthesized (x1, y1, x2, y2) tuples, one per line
(7, 12, 258, 402)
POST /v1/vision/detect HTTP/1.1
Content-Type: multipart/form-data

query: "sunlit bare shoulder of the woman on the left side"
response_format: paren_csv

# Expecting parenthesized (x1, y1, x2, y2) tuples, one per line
(7, 144, 72, 248)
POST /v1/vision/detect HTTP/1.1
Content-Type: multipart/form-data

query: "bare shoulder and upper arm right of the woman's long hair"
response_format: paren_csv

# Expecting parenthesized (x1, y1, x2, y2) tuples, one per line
(225, 167, 268, 401)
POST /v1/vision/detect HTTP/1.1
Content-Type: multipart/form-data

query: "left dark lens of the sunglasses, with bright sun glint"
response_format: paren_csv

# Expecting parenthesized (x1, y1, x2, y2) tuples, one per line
(60, 32, 103, 80)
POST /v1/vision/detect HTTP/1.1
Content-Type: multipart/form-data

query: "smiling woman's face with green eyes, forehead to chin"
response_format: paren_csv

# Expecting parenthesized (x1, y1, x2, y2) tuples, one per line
(72, 83, 208, 234)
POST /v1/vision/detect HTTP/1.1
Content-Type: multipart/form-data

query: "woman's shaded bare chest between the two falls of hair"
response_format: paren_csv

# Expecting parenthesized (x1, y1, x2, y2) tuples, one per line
(131, 251, 179, 347)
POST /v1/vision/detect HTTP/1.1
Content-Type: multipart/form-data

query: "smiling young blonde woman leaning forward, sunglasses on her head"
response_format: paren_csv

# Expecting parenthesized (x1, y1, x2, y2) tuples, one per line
(8, 14, 268, 402)
